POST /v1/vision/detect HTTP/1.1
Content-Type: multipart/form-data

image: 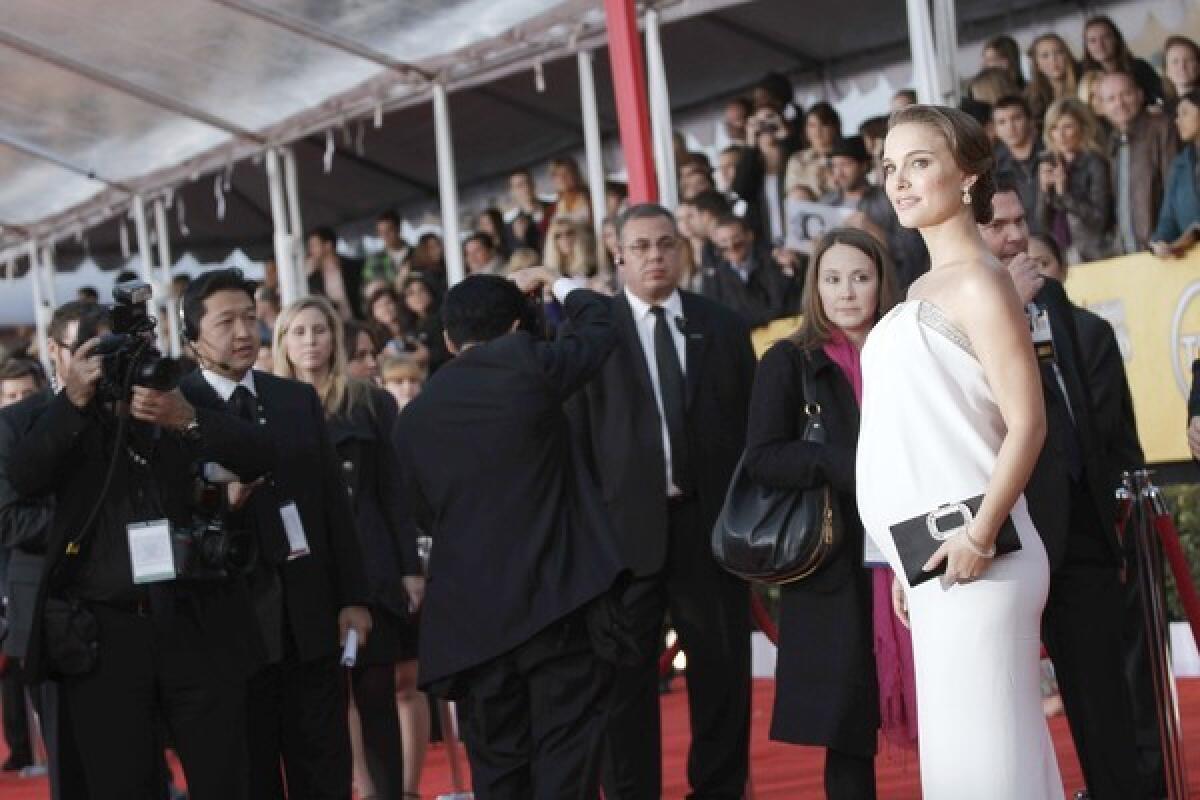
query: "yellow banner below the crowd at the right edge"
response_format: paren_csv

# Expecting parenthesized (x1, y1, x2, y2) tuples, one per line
(1067, 248, 1200, 463)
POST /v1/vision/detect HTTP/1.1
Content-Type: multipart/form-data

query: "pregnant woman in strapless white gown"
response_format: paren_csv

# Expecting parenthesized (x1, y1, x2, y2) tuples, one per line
(857, 106, 1063, 800)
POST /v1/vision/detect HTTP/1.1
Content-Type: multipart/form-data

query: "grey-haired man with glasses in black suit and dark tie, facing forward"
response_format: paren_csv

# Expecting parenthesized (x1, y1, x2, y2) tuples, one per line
(571, 204, 755, 800)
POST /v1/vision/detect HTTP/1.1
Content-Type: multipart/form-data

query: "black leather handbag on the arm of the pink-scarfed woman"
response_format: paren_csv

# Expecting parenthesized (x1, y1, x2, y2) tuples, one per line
(712, 354, 844, 584)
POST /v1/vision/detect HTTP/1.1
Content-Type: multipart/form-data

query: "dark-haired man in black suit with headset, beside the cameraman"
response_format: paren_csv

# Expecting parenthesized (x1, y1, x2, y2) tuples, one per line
(181, 270, 371, 800)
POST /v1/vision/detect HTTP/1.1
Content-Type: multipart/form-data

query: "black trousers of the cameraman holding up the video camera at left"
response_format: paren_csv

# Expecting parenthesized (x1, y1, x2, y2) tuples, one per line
(60, 606, 248, 800)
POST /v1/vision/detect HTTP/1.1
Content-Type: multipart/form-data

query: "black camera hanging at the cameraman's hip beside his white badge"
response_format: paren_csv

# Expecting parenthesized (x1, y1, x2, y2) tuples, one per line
(170, 474, 258, 581)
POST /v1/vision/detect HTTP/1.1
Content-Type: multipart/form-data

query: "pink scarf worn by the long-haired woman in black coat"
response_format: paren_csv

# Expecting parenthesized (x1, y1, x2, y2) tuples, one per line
(822, 329, 917, 750)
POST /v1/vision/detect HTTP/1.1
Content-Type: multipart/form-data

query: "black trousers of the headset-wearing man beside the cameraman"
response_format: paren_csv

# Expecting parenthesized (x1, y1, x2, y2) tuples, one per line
(246, 655, 350, 800)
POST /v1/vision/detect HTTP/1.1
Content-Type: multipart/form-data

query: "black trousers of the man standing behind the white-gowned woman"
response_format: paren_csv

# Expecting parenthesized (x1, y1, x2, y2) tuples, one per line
(1042, 485, 1145, 800)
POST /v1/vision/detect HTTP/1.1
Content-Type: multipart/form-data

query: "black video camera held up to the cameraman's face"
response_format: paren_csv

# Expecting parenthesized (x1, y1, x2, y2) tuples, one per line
(94, 281, 182, 402)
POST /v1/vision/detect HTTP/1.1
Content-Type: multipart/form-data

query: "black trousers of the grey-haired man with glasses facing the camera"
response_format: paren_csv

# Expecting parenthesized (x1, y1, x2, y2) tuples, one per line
(604, 500, 750, 800)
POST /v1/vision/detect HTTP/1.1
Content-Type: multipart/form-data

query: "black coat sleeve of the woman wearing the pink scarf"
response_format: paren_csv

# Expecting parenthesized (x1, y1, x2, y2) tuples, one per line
(745, 342, 854, 493)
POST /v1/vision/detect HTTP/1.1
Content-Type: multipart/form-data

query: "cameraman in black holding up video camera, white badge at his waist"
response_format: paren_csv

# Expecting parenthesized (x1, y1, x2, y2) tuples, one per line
(7, 282, 271, 800)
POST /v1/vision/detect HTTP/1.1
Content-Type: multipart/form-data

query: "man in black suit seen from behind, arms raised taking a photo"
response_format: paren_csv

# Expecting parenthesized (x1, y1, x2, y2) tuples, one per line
(395, 267, 623, 800)
